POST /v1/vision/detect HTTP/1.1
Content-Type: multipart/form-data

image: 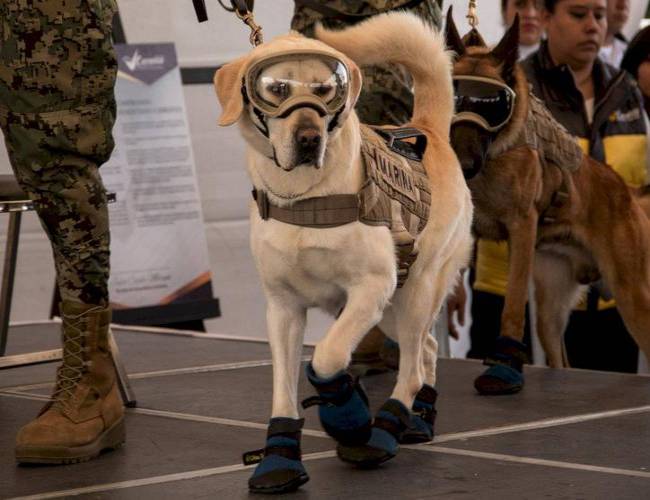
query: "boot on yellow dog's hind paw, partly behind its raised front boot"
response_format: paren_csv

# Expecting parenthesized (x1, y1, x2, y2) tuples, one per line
(336, 399, 411, 469)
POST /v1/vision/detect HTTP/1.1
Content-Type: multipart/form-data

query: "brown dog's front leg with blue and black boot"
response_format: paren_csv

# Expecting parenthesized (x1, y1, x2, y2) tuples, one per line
(474, 215, 538, 395)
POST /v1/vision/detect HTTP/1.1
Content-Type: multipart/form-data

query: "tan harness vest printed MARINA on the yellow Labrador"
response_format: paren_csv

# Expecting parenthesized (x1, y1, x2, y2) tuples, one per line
(253, 125, 431, 287)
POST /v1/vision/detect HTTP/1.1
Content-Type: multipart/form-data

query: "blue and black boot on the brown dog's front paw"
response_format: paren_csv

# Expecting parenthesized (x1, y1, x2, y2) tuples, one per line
(474, 337, 528, 395)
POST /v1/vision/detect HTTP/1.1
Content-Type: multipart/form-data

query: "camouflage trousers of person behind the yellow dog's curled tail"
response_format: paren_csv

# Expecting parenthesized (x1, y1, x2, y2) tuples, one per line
(291, 0, 441, 125)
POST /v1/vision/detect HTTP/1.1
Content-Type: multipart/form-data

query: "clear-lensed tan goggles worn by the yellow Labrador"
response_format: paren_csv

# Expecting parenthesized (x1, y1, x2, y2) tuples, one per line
(244, 51, 350, 118)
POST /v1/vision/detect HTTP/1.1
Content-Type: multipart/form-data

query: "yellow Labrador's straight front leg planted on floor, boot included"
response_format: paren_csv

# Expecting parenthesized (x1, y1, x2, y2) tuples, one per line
(244, 294, 309, 493)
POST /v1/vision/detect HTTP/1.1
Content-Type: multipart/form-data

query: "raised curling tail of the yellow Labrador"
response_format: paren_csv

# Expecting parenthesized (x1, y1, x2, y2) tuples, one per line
(316, 12, 454, 137)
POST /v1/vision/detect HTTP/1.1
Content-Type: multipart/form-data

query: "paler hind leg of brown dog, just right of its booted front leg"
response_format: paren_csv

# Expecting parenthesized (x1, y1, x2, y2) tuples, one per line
(534, 252, 585, 368)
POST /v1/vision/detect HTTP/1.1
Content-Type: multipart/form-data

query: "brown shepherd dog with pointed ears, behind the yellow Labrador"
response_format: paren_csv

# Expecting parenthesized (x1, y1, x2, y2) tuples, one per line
(446, 12, 650, 394)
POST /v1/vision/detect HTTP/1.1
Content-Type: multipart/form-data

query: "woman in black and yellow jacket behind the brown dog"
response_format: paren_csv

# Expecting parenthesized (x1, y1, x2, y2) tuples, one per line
(522, 0, 648, 372)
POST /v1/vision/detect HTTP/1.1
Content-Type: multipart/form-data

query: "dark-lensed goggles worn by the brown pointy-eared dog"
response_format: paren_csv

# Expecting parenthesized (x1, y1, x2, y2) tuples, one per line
(452, 75, 516, 132)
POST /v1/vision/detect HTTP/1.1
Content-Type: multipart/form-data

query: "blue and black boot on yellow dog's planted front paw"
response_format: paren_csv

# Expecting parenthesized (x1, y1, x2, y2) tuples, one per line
(243, 417, 309, 493)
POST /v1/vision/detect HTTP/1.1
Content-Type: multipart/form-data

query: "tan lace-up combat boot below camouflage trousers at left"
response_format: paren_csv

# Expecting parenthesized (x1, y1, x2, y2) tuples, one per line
(16, 302, 125, 464)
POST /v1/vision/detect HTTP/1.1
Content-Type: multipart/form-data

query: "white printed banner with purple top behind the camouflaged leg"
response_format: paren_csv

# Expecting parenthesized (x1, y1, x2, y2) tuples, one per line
(101, 44, 212, 316)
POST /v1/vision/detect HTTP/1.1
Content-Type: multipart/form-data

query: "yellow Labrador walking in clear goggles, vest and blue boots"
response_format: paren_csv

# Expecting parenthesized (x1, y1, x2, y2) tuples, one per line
(215, 13, 472, 493)
